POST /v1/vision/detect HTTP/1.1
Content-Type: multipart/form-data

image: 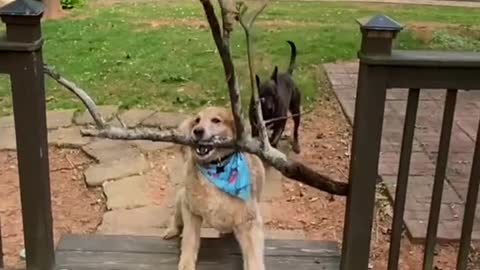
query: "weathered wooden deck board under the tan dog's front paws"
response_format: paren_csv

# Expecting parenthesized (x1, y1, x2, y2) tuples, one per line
(56, 235, 340, 270)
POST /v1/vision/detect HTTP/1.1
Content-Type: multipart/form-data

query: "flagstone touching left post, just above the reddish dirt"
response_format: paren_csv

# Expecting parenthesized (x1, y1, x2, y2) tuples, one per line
(48, 127, 92, 147)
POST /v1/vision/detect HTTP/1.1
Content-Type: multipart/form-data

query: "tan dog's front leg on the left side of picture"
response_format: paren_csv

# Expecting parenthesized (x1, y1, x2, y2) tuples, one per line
(178, 204, 202, 270)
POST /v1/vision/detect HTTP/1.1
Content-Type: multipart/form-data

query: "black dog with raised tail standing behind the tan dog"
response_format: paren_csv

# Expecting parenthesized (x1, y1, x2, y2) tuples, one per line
(249, 41, 301, 153)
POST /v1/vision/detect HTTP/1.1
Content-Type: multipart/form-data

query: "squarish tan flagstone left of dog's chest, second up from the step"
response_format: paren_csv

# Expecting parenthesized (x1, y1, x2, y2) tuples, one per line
(103, 175, 152, 210)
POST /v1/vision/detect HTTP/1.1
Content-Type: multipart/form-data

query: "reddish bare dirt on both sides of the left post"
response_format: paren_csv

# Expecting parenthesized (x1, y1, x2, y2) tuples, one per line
(0, 148, 105, 267)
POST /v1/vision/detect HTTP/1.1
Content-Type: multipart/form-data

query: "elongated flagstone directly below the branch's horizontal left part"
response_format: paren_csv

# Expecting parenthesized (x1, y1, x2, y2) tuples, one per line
(82, 139, 141, 162)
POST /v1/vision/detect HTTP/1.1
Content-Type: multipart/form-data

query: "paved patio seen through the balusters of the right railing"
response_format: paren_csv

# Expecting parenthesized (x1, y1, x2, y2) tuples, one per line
(325, 62, 480, 241)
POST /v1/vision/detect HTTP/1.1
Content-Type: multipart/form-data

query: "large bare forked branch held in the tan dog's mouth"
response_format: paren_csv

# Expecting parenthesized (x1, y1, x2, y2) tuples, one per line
(45, 0, 348, 195)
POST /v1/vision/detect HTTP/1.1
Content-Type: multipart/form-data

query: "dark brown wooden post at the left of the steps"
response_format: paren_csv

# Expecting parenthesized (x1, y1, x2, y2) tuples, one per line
(0, 0, 55, 270)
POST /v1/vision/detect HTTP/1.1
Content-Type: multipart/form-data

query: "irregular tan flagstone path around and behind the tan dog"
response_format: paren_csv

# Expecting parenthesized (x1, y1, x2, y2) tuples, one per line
(0, 106, 305, 239)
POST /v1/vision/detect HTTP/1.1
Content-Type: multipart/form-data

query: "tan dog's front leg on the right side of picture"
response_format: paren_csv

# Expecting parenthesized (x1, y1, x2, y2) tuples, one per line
(235, 220, 265, 270)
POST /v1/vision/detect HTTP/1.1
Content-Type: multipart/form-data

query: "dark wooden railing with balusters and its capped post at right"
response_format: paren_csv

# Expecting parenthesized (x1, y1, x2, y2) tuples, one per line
(341, 15, 480, 270)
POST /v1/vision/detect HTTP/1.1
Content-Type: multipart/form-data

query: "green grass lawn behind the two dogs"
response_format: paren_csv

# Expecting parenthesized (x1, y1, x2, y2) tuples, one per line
(0, 1, 480, 114)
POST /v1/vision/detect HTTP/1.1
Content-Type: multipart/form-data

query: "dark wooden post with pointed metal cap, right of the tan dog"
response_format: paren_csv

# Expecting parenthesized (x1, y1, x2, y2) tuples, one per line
(340, 15, 401, 270)
